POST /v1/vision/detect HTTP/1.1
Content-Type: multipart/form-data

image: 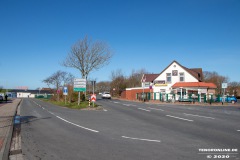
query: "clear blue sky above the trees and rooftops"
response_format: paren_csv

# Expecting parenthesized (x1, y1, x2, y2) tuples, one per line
(0, 0, 240, 89)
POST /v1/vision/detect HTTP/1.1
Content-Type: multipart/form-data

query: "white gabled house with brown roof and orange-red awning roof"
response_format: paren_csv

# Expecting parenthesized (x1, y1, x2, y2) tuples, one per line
(121, 61, 217, 100)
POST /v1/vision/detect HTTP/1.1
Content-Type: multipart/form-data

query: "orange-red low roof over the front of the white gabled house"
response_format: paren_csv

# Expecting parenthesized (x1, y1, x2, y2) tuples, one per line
(172, 82, 217, 88)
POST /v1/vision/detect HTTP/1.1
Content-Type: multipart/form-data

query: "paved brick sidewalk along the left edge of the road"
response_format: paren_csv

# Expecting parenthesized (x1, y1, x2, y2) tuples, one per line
(0, 99, 21, 160)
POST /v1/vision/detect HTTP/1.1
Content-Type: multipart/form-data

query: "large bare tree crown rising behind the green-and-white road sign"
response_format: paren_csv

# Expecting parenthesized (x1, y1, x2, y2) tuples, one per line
(62, 36, 112, 79)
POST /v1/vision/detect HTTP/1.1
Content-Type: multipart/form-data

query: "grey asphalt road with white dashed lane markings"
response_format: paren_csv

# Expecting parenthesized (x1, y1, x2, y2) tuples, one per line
(20, 99, 240, 160)
